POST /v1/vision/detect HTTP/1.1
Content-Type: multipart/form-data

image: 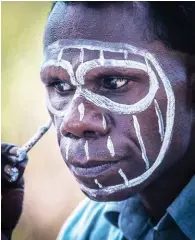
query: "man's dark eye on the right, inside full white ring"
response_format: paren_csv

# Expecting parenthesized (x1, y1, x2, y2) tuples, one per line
(102, 77, 128, 89)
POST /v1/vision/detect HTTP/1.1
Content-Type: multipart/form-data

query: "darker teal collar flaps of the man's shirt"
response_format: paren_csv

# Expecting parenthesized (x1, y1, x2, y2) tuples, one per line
(105, 176, 195, 239)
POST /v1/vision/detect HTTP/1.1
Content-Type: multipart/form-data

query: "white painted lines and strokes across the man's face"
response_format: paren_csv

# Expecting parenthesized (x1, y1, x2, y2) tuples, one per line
(41, 40, 175, 196)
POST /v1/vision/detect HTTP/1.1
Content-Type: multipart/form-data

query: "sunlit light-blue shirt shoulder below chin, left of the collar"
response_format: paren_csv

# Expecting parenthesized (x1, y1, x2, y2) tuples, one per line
(57, 199, 122, 240)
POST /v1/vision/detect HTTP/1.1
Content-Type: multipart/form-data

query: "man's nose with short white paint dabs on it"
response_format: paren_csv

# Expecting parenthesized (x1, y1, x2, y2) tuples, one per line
(60, 101, 109, 138)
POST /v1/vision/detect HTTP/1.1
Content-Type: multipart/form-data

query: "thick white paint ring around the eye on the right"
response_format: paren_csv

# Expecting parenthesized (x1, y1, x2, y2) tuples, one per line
(76, 59, 159, 114)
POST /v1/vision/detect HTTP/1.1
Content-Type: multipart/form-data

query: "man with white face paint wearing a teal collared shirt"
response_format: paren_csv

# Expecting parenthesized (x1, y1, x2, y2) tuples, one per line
(1, 2, 195, 240)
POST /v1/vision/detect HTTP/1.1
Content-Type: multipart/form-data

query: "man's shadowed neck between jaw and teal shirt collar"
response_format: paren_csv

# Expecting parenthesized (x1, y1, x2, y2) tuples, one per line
(140, 147, 195, 223)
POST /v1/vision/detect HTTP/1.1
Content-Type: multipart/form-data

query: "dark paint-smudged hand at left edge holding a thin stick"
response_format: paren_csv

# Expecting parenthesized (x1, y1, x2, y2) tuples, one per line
(1, 143, 28, 239)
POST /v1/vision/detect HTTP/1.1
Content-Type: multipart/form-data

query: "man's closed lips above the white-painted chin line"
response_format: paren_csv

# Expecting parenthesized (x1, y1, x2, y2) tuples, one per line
(69, 161, 118, 177)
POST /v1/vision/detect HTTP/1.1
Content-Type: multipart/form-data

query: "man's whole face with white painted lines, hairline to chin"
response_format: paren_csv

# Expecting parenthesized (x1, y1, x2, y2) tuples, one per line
(41, 3, 192, 201)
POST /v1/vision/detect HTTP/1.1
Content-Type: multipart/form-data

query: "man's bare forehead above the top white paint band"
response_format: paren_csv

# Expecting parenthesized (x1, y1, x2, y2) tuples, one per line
(44, 2, 154, 48)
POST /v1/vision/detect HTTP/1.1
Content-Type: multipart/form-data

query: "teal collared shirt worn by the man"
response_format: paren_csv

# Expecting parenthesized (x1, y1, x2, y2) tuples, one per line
(57, 176, 195, 240)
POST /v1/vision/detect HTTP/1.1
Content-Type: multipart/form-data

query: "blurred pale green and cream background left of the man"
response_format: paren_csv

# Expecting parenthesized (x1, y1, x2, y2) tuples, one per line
(1, 2, 83, 240)
